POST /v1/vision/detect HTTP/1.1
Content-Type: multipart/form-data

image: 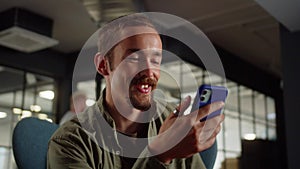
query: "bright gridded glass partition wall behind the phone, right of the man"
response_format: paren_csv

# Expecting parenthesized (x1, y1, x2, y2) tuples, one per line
(160, 61, 276, 169)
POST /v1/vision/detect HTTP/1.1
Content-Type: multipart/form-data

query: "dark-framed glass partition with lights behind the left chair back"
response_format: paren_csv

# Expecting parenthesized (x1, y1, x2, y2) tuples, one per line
(0, 66, 55, 169)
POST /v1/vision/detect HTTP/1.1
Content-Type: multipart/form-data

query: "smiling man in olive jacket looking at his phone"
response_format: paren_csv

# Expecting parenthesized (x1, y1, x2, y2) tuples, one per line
(47, 14, 224, 169)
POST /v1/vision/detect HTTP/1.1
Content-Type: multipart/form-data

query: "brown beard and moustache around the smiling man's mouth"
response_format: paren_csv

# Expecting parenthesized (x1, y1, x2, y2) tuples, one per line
(129, 76, 158, 111)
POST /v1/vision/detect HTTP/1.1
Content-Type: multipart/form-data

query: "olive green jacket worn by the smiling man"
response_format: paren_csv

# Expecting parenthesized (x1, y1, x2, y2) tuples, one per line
(47, 93, 205, 169)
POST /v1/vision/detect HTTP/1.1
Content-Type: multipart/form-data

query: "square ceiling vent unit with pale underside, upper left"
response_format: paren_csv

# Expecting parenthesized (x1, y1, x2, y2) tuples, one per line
(0, 8, 58, 53)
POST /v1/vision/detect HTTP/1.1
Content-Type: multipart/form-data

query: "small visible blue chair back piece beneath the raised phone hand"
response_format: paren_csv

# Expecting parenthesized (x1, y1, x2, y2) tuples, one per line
(199, 141, 218, 169)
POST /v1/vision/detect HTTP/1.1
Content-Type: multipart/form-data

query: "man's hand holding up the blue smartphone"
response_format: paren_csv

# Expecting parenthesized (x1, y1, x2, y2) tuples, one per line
(149, 97, 224, 164)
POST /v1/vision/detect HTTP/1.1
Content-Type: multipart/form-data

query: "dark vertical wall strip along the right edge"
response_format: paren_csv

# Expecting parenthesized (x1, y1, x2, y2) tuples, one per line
(280, 26, 300, 169)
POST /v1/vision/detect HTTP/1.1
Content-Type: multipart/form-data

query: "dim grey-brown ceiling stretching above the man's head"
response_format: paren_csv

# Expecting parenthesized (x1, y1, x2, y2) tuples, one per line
(0, 0, 292, 77)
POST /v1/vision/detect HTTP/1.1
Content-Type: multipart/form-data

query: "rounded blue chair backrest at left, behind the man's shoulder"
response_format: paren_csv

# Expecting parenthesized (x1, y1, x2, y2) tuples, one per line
(12, 117, 59, 169)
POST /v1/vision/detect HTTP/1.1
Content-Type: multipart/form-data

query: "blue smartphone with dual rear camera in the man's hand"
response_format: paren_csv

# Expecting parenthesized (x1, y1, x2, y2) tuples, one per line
(191, 84, 228, 122)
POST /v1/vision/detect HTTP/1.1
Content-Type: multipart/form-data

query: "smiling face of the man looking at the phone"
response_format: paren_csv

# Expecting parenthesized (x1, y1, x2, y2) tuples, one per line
(110, 27, 162, 110)
